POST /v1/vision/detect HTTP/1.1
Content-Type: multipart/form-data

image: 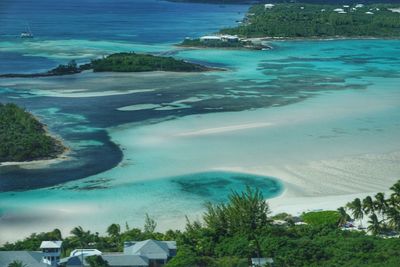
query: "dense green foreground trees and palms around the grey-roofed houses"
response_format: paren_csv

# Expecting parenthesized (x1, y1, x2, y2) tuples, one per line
(0, 180, 400, 267)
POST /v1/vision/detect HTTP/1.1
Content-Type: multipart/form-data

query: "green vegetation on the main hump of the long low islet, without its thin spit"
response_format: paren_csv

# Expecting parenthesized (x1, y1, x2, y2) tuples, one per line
(91, 52, 211, 72)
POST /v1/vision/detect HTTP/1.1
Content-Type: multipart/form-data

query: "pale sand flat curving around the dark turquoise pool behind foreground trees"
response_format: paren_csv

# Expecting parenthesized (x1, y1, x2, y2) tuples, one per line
(0, 77, 400, 245)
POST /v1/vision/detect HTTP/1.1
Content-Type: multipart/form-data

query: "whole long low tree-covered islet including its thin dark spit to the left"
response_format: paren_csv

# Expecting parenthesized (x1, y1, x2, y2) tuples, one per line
(0, 52, 222, 78)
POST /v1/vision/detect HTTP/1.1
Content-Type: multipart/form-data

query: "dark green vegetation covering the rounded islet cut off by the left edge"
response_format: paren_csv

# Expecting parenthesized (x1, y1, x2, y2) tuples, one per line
(0, 103, 64, 162)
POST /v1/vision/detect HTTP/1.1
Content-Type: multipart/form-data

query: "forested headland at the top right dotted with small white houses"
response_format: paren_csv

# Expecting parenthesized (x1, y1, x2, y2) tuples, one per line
(221, 4, 400, 38)
